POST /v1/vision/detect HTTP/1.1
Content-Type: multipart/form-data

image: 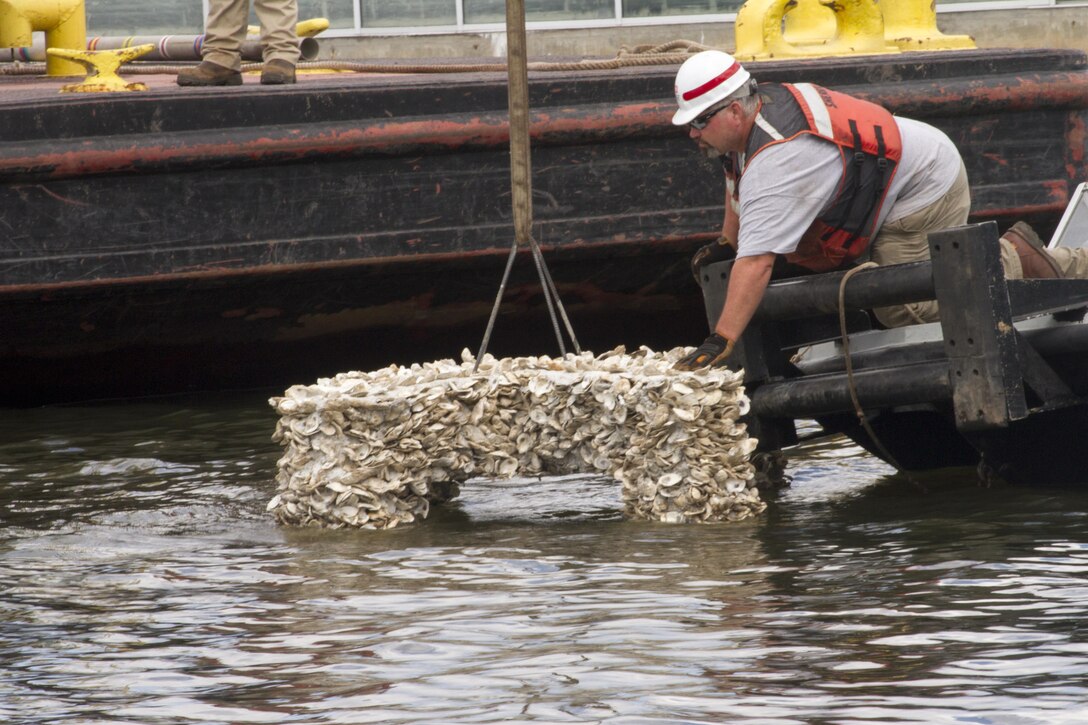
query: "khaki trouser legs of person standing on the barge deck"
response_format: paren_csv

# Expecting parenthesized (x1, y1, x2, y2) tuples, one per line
(201, 0, 298, 71)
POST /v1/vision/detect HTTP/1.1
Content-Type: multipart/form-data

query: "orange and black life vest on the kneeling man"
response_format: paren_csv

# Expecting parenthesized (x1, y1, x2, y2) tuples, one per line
(725, 83, 903, 267)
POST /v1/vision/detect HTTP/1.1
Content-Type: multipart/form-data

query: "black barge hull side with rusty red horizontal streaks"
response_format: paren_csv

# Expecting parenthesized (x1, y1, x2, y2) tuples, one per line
(0, 50, 1088, 405)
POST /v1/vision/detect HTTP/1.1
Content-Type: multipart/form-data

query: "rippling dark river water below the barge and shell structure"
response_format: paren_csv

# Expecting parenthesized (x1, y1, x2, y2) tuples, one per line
(0, 391, 1088, 725)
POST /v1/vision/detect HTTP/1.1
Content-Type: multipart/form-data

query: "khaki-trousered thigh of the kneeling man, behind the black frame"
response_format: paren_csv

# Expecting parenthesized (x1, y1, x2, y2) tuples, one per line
(870, 164, 974, 328)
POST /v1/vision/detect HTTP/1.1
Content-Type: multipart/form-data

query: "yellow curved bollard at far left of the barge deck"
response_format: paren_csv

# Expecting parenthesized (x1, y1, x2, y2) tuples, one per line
(0, 0, 87, 75)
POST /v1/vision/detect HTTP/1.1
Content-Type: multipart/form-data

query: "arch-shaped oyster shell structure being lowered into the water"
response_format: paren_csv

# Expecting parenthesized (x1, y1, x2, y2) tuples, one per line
(268, 347, 766, 529)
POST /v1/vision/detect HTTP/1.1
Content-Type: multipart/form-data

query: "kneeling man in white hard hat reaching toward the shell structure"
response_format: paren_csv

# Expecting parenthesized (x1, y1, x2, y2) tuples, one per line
(672, 50, 1088, 370)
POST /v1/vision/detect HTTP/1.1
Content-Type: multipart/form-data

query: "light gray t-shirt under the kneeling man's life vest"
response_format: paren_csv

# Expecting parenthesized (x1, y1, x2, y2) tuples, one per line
(737, 116, 962, 257)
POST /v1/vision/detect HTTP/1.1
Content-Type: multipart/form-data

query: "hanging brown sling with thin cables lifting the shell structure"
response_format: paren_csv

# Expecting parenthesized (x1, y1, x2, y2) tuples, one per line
(472, 0, 582, 372)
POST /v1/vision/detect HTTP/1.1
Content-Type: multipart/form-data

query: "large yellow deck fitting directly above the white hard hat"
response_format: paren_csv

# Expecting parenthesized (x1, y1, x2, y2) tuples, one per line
(734, 0, 899, 60)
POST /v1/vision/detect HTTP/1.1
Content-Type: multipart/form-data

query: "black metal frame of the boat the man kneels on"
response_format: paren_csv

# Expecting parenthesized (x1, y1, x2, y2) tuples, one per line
(702, 222, 1088, 483)
